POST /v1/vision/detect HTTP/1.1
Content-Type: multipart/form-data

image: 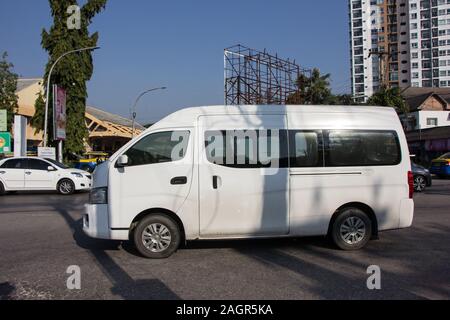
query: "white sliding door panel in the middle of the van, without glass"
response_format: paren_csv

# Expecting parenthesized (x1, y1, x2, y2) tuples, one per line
(198, 114, 289, 238)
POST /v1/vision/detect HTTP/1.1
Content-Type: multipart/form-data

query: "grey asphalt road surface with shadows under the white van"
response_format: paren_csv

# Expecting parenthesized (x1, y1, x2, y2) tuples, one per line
(0, 180, 450, 299)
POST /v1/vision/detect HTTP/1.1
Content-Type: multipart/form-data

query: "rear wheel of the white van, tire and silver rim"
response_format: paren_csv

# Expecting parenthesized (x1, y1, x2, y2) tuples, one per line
(331, 208, 372, 250)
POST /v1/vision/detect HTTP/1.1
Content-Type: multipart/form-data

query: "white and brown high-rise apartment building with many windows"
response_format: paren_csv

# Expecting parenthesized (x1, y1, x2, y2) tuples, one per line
(349, 0, 450, 102)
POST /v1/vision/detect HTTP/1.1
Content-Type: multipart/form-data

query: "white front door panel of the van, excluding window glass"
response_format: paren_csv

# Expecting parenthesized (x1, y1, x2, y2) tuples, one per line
(108, 128, 194, 229)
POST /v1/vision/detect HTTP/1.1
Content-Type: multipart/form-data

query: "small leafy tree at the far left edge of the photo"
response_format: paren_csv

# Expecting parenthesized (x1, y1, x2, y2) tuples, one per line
(0, 52, 18, 131)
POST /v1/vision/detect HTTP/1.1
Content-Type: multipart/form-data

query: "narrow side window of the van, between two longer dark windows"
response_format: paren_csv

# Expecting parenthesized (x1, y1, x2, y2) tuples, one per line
(289, 130, 323, 168)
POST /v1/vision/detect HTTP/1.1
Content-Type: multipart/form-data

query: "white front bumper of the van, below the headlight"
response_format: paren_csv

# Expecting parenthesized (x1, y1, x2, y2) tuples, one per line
(83, 204, 129, 240)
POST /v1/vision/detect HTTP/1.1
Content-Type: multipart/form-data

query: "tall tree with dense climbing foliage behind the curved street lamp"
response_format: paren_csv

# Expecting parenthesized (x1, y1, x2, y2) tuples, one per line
(31, 0, 107, 154)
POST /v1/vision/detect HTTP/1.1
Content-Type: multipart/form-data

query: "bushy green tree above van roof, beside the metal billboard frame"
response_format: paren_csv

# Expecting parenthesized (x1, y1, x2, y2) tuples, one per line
(286, 68, 332, 104)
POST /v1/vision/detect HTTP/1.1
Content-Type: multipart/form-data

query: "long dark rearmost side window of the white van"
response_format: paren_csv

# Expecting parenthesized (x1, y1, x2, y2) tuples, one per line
(325, 130, 401, 167)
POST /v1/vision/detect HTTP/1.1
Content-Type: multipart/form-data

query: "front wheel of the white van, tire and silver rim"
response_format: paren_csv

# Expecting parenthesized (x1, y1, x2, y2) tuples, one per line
(133, 214, 181, 259)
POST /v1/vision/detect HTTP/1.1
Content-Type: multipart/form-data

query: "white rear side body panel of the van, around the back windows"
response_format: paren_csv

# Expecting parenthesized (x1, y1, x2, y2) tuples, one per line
(287, 108, 411, 236)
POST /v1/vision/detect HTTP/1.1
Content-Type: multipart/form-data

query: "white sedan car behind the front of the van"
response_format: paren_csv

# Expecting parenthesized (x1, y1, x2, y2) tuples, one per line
(0, 157, 91, 195)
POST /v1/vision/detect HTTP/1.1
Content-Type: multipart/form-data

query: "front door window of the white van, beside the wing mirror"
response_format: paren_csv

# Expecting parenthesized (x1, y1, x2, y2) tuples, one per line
(125, 131, 190, 166)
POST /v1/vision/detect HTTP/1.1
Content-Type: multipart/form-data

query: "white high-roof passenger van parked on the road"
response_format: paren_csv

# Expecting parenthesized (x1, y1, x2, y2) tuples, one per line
(83, 105, 414, 258)
